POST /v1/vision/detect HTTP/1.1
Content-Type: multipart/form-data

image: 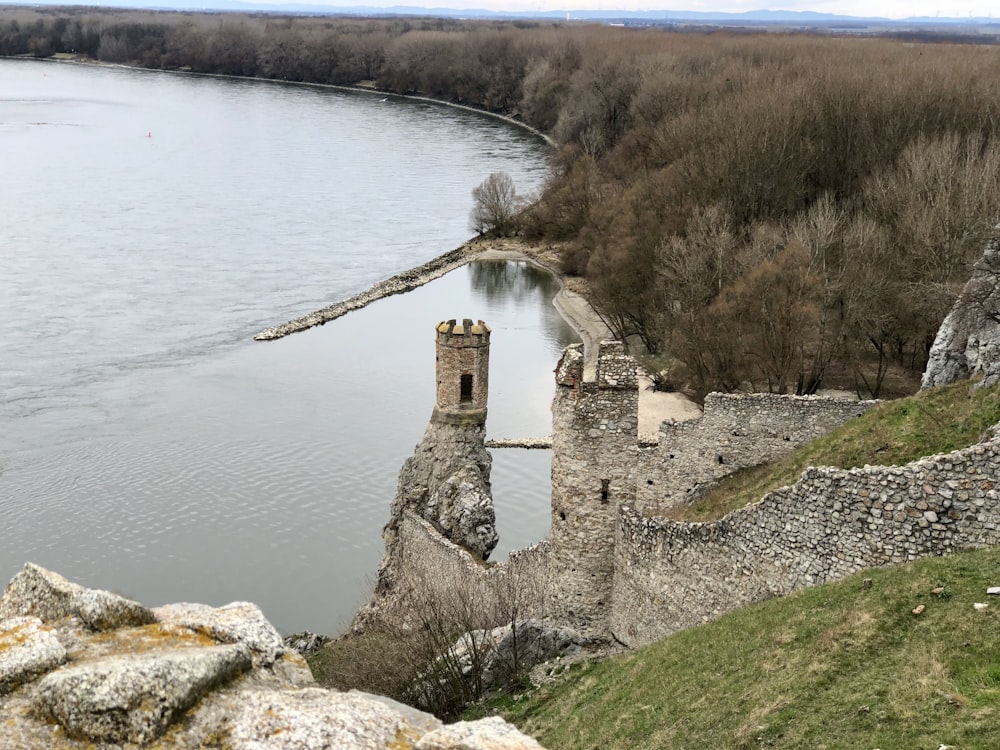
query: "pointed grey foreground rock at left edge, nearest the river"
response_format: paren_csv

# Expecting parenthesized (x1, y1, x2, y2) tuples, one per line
(0, 563, 153, 630)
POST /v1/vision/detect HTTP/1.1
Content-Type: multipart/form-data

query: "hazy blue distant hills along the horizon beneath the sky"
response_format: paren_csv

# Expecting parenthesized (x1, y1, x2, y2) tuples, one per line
(0, 0, 1000, 27)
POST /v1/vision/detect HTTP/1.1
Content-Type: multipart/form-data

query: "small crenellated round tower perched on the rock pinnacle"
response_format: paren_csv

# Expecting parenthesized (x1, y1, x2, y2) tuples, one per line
(433, 318, 490, 424)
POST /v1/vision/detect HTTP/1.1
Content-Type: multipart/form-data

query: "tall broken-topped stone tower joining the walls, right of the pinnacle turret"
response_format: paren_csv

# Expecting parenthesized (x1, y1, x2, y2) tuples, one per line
(546, 341, 639, 635)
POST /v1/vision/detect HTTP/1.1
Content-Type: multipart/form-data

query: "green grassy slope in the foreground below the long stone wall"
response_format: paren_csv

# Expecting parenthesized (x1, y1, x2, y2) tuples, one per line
(495, 549, 1000, 750)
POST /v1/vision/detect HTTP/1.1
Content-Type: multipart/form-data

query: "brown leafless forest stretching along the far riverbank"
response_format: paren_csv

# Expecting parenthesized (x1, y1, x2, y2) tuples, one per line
(7, 8, 1000, 397)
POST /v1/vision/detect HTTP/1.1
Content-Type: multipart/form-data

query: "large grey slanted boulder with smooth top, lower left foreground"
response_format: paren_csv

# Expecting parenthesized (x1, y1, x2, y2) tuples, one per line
(34, 644, 251, 742)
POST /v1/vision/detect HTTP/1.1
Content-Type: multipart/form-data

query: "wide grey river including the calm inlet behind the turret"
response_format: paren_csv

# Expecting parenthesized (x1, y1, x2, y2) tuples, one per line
(0, 61, 573, 632)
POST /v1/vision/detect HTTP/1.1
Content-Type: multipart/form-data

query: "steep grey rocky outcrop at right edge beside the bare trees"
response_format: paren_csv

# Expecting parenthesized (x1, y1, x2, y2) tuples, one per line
(921, 225, 1000, 388)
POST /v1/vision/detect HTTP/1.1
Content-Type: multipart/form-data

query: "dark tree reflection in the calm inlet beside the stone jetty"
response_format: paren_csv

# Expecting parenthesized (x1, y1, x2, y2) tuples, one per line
(469, 260, 580, 349)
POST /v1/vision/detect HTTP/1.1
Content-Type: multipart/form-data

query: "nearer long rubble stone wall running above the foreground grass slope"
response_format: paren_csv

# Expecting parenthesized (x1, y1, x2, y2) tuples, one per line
(611, 437, 1000, 646)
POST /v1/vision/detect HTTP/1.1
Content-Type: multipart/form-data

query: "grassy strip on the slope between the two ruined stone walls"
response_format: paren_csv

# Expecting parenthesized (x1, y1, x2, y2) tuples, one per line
(665, 381, 1000, 524)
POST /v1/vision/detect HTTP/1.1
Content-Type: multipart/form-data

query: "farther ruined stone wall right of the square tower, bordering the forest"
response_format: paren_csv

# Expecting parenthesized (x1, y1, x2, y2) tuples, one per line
(636, 393, 878, 515)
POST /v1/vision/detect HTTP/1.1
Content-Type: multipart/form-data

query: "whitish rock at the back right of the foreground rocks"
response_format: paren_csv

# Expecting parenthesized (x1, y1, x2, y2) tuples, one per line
(152, 602, 285, 666)
